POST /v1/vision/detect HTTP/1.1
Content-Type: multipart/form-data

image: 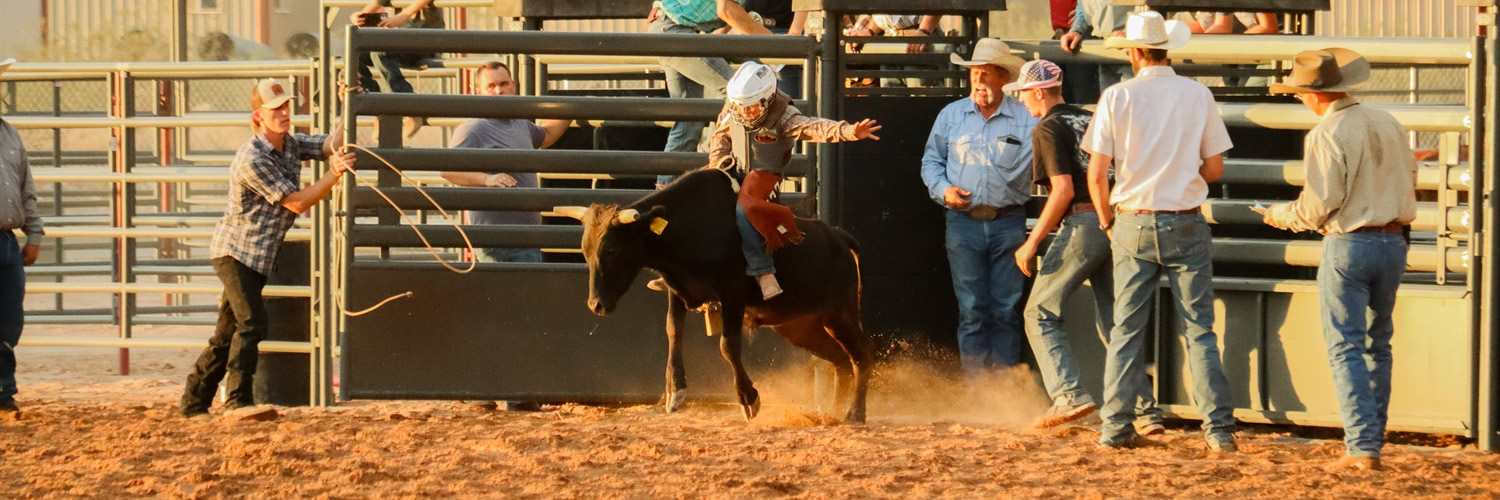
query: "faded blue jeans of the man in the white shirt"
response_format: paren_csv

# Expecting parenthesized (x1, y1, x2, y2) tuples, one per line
(1100, 213, 1235, 444)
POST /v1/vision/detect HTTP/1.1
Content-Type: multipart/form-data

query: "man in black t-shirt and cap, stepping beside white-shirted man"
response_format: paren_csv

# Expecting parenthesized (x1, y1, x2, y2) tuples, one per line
(1004, 60, 1166, 434)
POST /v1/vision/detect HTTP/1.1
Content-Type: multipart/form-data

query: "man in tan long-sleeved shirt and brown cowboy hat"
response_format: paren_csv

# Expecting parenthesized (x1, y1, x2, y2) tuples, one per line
(1257, 48, 1416, 468)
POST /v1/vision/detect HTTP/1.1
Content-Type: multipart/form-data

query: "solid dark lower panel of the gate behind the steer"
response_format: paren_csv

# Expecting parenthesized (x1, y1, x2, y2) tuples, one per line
(341, 264, 806, 402)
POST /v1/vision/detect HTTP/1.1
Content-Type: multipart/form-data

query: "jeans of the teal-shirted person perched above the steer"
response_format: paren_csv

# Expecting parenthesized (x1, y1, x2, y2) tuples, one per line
(647, 15, 734, 185)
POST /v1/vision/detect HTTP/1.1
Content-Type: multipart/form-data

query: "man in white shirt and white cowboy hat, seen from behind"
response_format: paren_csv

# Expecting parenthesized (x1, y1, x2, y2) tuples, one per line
(1083, 12, 1236, 452)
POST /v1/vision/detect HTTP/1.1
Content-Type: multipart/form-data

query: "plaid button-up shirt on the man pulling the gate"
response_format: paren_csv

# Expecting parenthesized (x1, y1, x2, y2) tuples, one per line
(209, 134, 327, 275)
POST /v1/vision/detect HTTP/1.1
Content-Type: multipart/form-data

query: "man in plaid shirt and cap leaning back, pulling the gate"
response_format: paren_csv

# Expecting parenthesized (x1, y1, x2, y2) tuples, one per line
(182, 80, 354, 419)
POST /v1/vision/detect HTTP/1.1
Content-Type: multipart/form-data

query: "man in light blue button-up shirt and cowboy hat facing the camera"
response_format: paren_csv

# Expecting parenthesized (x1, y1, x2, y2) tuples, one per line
(923, 38, 1037, 380)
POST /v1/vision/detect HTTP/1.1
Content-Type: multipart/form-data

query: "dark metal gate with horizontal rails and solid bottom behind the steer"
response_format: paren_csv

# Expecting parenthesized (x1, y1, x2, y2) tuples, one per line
(325, 27, 818, 402)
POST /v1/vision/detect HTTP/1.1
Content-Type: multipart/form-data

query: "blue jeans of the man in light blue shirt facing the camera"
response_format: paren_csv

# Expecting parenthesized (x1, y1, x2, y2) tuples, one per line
(947, 209, 1026, 378)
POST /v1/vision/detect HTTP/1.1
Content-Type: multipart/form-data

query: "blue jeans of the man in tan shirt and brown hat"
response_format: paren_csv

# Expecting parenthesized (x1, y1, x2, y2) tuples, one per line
(1317, 233, 1407, 458)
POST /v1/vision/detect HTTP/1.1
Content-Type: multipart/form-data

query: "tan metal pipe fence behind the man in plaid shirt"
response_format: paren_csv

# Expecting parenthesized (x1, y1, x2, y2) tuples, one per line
(5, 60, 315, 374)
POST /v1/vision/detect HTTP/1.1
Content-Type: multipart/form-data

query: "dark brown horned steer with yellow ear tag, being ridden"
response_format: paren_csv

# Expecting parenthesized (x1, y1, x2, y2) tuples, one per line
(554, 168, 875, 423)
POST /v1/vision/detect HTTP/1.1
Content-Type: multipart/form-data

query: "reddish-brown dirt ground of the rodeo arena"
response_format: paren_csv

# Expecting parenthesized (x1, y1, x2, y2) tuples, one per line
(0, 325, 1500, 498)
